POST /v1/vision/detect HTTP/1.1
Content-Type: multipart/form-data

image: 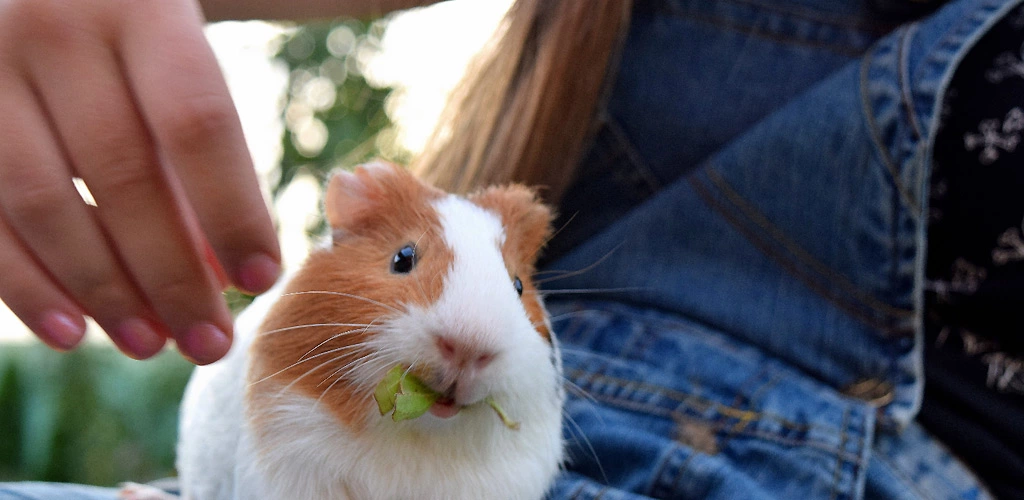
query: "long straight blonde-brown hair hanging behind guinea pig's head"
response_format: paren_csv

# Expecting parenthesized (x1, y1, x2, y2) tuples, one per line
(411, 0, 633, 203)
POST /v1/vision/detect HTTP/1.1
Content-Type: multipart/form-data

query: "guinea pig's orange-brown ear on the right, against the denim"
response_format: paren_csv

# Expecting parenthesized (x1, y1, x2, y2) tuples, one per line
(469, 184, 554, 264)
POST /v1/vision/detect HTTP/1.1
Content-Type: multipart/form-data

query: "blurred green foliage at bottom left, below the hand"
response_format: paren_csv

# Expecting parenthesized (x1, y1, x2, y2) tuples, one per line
(0, 344, 191, 485)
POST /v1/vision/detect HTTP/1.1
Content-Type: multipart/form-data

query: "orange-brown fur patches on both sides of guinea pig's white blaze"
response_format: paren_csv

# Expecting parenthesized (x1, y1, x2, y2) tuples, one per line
(247, 167, 551, 432)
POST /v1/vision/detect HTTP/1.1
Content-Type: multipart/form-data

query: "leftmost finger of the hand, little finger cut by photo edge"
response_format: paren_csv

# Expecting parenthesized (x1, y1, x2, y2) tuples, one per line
(0, 220, 85, 350)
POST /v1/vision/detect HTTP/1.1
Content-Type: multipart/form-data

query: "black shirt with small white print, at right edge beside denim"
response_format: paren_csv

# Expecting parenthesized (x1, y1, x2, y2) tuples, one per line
(920, 4, 1024, 498)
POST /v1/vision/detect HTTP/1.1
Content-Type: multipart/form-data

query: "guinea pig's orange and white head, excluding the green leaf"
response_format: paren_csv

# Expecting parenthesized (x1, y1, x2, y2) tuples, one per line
(250, 163, 562, 428)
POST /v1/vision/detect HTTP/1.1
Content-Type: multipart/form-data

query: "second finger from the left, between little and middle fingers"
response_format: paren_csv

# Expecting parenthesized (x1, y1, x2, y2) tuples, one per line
(0, 73, 164, 359)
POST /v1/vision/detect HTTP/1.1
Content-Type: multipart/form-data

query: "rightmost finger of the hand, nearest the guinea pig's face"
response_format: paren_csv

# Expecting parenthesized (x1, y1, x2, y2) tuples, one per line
(120, 2, 281, 293)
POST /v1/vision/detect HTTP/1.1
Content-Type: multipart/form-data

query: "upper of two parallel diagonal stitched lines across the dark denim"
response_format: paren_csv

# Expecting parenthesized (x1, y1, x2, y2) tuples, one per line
(708, 168, 912, 318)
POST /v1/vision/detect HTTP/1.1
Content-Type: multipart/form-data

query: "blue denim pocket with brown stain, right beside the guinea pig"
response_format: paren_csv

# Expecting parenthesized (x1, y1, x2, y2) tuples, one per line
(553, 302, 874, 499)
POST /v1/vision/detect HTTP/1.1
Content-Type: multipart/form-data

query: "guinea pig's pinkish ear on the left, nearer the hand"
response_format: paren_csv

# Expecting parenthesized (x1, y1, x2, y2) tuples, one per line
(324, 162, 401, 235)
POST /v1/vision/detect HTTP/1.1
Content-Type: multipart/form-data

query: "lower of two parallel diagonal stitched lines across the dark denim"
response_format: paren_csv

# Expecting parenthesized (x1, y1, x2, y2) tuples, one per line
(687, 175, 910, 335)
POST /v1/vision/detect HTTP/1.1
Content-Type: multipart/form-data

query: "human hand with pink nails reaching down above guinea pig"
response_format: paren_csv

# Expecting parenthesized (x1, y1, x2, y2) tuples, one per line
(0, 0, 280, 364)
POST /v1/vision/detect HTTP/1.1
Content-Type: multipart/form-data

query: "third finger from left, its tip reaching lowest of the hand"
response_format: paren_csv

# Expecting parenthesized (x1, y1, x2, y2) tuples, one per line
(24, 27, 231, 364)
